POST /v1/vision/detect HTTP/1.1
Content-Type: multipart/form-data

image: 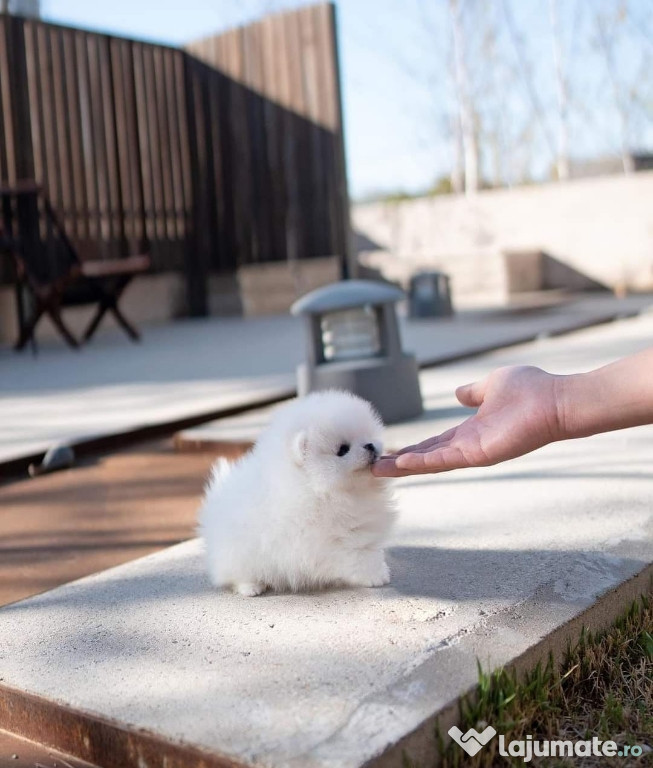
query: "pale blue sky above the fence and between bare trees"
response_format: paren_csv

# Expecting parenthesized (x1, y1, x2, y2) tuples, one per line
(41, 0, 653, 199)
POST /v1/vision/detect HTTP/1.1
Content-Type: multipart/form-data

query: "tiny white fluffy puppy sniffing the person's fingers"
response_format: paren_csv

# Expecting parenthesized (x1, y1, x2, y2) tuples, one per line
(199, 391, 395, 596)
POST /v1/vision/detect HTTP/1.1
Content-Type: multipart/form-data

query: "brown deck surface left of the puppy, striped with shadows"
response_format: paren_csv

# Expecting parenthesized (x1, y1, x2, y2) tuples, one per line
(0, 441, 222, 605)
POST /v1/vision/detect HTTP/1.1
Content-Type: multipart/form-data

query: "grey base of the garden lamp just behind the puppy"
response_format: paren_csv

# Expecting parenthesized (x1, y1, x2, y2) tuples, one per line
(297, 355, 423, 424)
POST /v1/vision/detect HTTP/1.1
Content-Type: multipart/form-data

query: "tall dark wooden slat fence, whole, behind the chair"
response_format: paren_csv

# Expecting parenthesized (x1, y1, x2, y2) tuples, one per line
(0, 4, 348, 314)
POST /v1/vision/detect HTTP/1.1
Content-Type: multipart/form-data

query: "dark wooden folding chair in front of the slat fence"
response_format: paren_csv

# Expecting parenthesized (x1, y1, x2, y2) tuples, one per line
(0, 182, 150, 349)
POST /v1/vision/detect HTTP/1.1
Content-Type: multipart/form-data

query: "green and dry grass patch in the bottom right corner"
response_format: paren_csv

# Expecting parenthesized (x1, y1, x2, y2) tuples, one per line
(436, 597, 653, 768)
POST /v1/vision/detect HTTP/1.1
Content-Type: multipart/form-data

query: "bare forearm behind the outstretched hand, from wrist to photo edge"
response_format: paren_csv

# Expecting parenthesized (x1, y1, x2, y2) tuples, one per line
(556, 347, 653, 440)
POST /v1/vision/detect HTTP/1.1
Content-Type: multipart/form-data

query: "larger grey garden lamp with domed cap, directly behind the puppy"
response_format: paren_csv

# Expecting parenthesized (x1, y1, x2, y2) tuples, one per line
(291, 280, 422, 423)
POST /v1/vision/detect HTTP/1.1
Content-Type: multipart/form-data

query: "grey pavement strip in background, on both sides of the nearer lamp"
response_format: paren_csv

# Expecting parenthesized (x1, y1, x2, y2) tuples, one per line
(0, 294, 653, 463)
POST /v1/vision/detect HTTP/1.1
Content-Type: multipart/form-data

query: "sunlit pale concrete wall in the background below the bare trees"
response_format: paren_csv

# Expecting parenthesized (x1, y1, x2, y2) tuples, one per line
(352, 172, 653, 304)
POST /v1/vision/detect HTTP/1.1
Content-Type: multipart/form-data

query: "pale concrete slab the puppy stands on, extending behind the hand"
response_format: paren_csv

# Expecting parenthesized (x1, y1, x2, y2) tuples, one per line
(0, 316, 653, 768)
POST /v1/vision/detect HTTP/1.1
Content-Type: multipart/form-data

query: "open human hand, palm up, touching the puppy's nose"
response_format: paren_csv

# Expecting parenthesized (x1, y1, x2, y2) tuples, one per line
(372, 366, 564, 477)
